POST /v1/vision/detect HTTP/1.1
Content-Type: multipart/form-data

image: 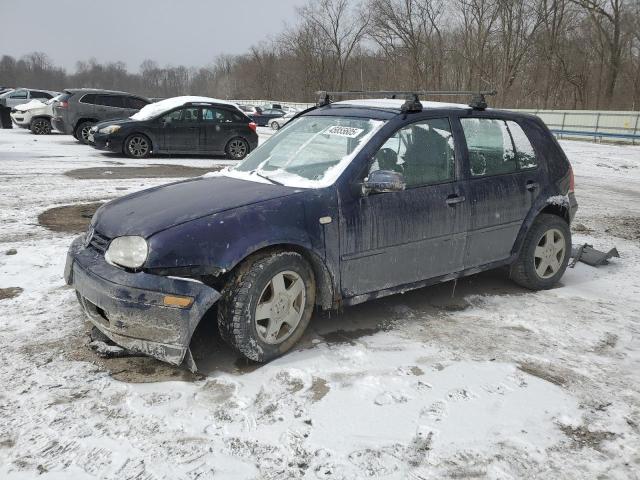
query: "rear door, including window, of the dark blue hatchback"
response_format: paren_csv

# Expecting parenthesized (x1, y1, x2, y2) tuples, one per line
(460, 118, 540, 268)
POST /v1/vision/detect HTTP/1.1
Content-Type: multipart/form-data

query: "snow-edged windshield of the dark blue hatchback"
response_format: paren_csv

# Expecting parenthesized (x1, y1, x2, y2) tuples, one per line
(232, 116, 385, 188)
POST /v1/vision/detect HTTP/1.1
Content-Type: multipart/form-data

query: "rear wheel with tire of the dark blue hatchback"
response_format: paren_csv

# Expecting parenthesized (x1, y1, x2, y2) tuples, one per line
(510, 213, 571, 290)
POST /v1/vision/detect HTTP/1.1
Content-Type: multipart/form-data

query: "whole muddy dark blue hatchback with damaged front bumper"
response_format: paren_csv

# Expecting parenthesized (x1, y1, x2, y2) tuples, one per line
(65, 94, 577, 368)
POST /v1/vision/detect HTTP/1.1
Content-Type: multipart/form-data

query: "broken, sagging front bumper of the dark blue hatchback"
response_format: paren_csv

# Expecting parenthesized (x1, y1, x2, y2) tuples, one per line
(64, 237, 220, 369)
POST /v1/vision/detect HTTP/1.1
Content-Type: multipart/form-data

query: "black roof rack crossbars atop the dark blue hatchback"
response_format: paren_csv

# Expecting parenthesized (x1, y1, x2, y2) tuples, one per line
(316, 90, 498, 112)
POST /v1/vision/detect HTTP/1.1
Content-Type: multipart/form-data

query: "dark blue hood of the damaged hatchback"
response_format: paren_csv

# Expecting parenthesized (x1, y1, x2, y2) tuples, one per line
(93, 176, 301, 238)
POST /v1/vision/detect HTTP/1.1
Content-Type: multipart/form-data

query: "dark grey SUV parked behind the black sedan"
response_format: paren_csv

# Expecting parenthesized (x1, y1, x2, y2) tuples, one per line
(51, 88, 151, 143)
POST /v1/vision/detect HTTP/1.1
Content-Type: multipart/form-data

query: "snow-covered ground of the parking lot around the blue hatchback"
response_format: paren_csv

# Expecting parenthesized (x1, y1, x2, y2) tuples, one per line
(0, 130, 640, 480)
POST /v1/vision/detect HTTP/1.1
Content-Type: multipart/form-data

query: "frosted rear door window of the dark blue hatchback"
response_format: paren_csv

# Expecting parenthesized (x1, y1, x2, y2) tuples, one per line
(460, 118, 517, 177)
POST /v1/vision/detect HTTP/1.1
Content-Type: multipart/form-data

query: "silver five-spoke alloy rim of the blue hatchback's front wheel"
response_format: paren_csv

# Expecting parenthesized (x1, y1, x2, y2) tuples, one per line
(254, 270, 306, 345)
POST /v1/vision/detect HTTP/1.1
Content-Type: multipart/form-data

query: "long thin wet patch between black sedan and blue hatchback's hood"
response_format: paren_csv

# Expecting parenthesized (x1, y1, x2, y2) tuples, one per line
(65, 162, 222, 180)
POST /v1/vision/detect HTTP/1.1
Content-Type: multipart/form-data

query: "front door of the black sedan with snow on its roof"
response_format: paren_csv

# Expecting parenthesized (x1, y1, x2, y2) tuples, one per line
(161, 107, 200, 152)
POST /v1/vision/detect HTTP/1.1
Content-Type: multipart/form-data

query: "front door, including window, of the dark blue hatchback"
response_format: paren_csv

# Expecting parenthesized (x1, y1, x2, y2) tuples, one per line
(340, 117, 468, 297)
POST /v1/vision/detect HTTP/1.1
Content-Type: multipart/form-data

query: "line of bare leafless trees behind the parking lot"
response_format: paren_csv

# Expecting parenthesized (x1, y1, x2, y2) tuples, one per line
(0, 0, 640, 110)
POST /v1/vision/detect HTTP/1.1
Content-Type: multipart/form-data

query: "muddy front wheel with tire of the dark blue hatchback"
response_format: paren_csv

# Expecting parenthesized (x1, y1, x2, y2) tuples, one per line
(218, 251, 315, 362)
